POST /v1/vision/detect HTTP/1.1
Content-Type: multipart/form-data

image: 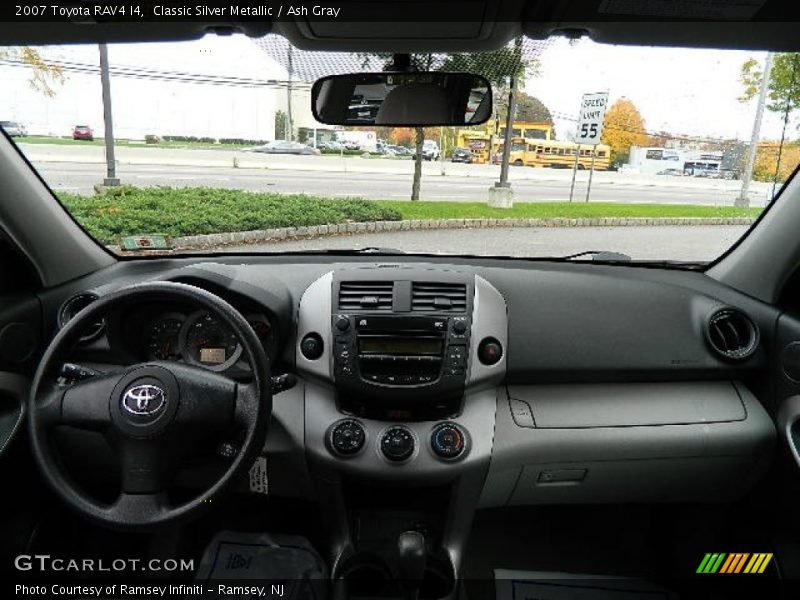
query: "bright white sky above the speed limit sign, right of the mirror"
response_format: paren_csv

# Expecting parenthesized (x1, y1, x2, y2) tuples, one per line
(525, 38, 797, 140)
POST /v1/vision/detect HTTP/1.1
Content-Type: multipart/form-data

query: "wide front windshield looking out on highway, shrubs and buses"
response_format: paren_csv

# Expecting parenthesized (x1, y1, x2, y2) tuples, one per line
(0, 35, 800, 262)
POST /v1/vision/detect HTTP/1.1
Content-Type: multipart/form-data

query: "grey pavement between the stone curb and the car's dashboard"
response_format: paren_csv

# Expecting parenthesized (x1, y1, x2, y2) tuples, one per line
(214, 225, 747, 261)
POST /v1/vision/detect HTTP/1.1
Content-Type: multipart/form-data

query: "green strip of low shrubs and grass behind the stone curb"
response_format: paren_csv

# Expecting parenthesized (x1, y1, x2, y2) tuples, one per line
(58, 186, 761, 244)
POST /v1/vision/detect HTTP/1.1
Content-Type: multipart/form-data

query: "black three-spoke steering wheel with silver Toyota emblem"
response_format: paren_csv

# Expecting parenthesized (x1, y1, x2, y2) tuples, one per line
(28, 282, 272, 529)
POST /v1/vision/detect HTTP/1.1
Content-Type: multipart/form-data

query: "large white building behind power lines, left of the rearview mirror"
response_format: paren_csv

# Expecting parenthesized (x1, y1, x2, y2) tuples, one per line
(0, 35, 325, 140)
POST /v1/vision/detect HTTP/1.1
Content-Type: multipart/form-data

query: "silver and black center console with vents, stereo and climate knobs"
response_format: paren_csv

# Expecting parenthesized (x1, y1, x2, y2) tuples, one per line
(296, 265, 508, 597)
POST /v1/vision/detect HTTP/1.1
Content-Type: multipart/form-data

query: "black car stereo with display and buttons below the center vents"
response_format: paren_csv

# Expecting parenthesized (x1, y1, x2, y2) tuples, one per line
(332, 314, 471, 400)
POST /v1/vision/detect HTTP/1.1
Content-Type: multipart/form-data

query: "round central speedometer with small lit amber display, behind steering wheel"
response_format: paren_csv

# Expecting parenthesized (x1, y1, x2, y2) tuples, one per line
(180, 310, 242, 371)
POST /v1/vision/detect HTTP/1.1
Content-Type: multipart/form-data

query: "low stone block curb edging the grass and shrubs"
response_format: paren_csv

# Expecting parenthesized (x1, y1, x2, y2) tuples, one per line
(109, 217, 755, 255)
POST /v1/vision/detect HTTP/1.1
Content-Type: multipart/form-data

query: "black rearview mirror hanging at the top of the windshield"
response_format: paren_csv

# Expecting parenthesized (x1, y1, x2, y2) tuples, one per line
(311, 71, 492, 127)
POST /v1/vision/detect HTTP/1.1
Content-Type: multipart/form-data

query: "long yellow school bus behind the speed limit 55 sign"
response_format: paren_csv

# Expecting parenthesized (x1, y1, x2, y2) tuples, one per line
(494, 138, 611, 171)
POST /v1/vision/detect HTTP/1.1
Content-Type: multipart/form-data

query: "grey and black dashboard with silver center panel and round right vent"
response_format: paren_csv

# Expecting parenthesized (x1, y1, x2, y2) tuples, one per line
(39, 257, 775, 506)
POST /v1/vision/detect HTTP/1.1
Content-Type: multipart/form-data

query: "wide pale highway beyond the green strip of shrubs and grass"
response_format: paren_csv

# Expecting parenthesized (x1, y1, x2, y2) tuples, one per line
(32, 161, 765, 206)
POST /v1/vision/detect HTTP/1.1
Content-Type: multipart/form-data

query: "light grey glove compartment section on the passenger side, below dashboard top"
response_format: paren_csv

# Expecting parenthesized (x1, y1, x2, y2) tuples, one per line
(481, 381, 775, 507)
